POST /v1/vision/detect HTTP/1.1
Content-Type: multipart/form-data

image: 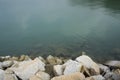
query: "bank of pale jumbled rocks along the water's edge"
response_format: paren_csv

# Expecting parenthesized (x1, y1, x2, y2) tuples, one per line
(0, 55, 120, 80)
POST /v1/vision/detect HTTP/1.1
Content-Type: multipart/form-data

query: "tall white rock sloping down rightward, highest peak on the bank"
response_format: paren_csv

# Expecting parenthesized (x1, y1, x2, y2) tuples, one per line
(76, 55, 100, 74)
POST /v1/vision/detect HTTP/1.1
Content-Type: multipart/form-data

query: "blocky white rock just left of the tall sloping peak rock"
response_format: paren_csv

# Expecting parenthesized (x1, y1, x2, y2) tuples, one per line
(64, 60, 83, 75)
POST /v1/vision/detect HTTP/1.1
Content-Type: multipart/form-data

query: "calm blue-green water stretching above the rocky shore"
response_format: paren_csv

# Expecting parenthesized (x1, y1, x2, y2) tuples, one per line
(0, 0, 120, 61)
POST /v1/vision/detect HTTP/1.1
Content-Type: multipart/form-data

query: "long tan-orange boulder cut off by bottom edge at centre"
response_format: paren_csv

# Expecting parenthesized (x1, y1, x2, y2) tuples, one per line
(51, 72, 85, 80)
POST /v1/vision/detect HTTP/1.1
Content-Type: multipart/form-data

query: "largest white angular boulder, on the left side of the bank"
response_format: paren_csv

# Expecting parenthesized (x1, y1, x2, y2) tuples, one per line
(10, 58, 45, 80)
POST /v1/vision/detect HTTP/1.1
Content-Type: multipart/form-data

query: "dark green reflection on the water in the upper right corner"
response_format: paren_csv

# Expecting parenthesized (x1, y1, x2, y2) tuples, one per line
(70, 0, 120, 13)
